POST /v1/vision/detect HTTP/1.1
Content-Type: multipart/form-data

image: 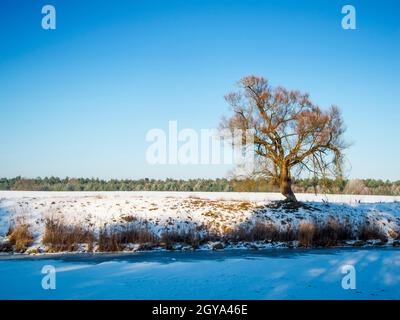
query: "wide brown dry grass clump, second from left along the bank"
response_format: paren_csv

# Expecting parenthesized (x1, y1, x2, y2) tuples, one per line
(42, 218, 95, 252)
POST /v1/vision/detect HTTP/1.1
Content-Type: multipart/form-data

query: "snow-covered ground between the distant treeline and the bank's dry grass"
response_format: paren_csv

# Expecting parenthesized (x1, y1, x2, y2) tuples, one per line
(0, 191, 400, 251)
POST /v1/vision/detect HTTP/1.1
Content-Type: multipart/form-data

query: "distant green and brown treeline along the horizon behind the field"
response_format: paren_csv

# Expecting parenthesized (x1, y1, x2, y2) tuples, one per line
(0, 177, 400, 196)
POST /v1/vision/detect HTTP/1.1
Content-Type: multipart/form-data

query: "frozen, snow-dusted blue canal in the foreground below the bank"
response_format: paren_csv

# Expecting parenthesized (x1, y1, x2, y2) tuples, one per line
(0, 248, 400, 299)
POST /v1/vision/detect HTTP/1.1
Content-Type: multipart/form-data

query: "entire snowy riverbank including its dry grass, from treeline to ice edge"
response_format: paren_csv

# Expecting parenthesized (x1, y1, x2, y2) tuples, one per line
(0, 192, 400, 254)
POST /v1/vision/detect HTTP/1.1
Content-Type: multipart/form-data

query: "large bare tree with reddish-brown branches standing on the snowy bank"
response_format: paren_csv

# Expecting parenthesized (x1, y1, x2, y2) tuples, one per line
(221, 76, 346, 201)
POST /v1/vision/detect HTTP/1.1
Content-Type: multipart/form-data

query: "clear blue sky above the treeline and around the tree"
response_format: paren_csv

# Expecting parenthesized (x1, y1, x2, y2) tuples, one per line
(0, 0, 400, 180)
